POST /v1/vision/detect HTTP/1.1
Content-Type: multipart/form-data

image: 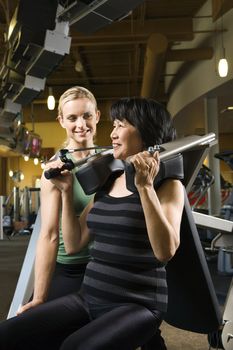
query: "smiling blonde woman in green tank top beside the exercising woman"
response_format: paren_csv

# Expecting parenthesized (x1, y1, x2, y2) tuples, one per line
(18, 86, 100, 314)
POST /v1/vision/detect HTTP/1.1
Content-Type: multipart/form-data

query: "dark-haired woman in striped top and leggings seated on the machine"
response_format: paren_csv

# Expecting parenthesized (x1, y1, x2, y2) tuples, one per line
(0, 98, 183, 350)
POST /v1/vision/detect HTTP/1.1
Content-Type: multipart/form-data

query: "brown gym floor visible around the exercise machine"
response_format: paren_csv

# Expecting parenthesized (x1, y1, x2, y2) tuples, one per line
(0, 235, 232, 350)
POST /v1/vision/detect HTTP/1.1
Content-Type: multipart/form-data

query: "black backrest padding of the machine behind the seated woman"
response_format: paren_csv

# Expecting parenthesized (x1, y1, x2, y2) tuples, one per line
(165, 191, 222, 334)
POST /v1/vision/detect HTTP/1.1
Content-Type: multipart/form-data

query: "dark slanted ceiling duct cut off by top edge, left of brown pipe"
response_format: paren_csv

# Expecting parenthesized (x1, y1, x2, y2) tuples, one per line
(59, 0, 144, 34)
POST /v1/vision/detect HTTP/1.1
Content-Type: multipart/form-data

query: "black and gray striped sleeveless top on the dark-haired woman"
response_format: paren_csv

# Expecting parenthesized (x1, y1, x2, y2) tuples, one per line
(82, 192, 167, 311)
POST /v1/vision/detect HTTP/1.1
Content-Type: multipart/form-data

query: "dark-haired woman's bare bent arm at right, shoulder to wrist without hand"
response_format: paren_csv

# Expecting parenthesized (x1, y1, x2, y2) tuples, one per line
(139, 180, 184, 262)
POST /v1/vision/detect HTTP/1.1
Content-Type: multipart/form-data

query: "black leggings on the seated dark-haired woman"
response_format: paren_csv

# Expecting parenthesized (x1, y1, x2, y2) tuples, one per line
(0, 294, 161, 350)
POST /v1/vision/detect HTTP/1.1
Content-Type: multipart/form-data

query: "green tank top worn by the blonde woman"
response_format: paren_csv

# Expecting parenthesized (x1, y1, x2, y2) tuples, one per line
(57, 154, 94, 264)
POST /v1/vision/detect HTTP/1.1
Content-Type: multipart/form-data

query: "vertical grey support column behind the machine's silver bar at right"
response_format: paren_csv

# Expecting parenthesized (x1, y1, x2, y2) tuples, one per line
(204, 97, 221, 216)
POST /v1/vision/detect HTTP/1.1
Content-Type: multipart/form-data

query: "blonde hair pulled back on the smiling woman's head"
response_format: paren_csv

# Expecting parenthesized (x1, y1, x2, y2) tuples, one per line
(58, 86, 97, 117)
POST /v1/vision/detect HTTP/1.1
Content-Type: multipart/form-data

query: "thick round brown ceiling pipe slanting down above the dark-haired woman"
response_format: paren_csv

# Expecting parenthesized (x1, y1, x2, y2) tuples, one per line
(141, 33, 168, 98)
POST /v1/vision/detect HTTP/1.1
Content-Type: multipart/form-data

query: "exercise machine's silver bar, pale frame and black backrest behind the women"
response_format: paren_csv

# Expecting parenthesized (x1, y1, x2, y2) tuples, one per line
(8, 133, 228, 342)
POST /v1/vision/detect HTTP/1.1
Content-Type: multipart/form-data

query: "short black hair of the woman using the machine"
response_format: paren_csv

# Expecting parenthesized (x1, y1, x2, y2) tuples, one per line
(110, 97, 176, 148)
